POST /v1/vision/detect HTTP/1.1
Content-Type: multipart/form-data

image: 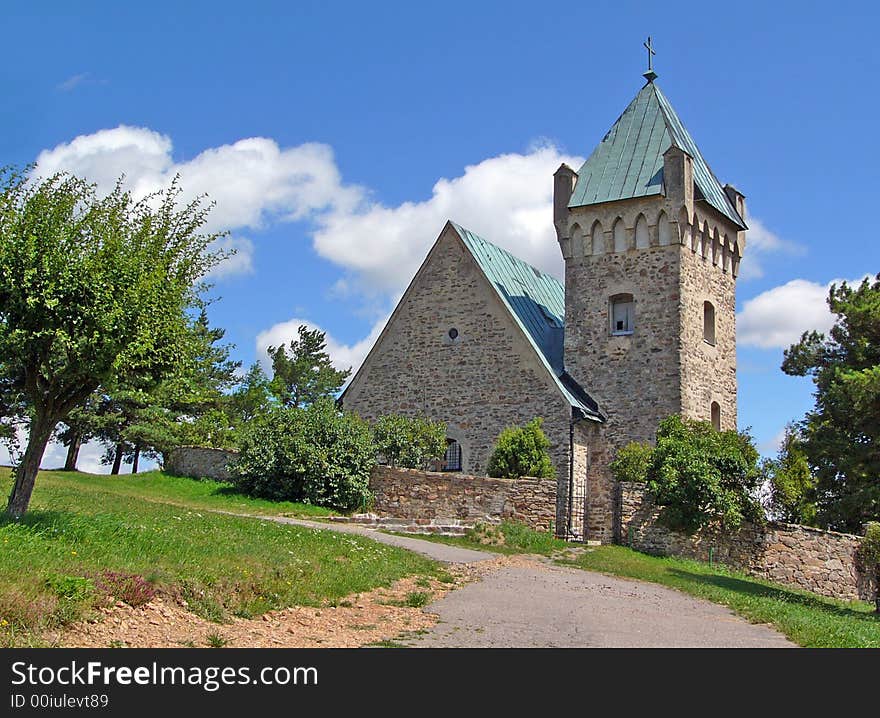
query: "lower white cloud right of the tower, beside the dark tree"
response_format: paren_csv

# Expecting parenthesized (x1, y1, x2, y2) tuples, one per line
(736, 278, 862, 349)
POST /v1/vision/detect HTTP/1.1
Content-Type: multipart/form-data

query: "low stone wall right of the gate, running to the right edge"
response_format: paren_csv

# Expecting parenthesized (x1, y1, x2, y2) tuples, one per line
(615, 482, 875, 601)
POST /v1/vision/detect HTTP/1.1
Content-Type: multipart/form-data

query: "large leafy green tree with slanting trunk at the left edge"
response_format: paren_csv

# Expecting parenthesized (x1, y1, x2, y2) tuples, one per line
(0, 169, 224, 517)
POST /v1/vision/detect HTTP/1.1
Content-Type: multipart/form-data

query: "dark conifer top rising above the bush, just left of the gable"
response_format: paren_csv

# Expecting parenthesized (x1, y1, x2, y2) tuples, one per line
(269, 324, 351, 407)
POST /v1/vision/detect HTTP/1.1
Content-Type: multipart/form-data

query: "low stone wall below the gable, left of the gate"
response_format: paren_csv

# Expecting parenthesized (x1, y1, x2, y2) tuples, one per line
(370, 466, 556, 531)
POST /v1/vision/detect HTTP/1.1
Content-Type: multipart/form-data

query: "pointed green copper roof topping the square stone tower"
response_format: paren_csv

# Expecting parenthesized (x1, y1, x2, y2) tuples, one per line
(568, 82, 745, 229)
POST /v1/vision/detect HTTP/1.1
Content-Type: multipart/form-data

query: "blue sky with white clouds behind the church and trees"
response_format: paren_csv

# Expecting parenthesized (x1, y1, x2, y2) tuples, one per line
(0, 0, 880, 468)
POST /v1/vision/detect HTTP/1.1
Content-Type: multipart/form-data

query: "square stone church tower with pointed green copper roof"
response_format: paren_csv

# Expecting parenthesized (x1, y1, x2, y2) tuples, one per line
(553, 73, 746, 448)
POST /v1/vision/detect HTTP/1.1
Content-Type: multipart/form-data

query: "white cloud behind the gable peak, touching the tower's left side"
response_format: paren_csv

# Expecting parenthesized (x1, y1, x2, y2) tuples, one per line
(314, 146, 582, 293)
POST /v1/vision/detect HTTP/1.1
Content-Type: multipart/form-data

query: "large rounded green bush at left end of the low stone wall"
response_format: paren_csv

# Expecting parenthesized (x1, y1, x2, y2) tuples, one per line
(230, 399, 376, 510)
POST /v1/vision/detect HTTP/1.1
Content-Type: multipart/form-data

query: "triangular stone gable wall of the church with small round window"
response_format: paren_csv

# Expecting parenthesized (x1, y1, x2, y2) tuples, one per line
(343, 228, 571, 528)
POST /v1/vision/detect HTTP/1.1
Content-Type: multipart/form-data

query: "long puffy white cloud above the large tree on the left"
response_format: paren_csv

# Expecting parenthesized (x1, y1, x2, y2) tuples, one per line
(35, 125, 365, 276)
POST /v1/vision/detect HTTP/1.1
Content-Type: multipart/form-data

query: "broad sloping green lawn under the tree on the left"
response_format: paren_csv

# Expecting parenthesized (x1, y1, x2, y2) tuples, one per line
(0, 471, 442, 646)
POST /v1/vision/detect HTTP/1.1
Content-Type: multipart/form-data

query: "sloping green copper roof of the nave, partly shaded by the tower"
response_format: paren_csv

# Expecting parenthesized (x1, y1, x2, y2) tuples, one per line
(450, 222, 599, 418)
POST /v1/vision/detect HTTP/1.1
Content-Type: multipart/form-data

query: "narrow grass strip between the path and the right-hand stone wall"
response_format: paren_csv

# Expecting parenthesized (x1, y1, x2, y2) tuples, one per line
(560, 546, 880, 648)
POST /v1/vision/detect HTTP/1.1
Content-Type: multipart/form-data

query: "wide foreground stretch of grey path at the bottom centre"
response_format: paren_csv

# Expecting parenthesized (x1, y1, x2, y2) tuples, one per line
(406, 560, 795, 648)
